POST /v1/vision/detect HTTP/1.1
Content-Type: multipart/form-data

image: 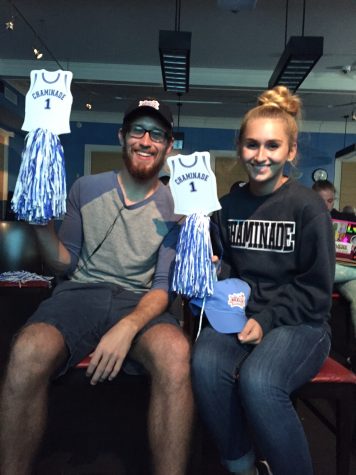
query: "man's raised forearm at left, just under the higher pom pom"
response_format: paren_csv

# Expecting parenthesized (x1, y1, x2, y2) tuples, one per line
(33, 221, 71, 274)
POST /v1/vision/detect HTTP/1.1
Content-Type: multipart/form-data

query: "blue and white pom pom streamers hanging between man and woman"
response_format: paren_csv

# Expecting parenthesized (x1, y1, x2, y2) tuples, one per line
(172, 214, 215, 298)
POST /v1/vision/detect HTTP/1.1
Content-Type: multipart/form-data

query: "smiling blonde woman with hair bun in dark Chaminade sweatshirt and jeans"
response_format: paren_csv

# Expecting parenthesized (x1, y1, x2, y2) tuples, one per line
(192, 86, 335, 475)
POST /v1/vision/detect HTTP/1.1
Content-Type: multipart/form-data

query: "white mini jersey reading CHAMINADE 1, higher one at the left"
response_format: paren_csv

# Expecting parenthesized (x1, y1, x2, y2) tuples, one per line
(22, 69, 73, 135)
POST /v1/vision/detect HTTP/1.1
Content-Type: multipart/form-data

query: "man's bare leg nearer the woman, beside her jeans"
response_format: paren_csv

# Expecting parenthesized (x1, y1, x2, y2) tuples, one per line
(130, 324, 193, 475)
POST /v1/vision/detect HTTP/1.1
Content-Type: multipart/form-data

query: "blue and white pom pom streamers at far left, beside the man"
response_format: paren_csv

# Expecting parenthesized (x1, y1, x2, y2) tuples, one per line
(11, 129, 67, 224)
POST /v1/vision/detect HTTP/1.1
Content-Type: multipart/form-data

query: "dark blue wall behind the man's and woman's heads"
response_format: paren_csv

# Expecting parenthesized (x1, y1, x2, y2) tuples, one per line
(0, 114, 356, 194)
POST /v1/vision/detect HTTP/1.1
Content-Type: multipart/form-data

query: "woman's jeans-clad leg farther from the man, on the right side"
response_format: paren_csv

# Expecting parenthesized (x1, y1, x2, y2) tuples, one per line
(239, 324, 330, 475)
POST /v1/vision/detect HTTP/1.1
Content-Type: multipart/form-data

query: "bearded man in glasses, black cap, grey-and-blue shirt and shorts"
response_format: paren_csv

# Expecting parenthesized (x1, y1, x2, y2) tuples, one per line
(0, 98, 193, 475)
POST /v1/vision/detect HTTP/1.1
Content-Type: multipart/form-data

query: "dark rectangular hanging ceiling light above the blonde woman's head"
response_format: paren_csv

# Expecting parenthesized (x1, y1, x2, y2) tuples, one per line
(268, 0, 324, 92)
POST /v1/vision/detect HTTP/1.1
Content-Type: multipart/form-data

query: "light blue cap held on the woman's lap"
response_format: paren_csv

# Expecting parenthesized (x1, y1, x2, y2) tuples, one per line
(189, 278, 251, 333)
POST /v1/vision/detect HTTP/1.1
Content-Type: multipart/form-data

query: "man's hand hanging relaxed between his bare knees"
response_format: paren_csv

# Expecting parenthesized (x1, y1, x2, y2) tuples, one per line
(86, 318, 137, 385)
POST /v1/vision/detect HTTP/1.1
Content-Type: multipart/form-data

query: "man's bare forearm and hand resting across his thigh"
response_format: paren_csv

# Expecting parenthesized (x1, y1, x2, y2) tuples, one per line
(87, 289, 169, 385)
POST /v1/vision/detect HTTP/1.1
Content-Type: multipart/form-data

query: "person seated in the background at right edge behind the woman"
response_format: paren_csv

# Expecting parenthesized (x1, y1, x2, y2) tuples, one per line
(312, 180, 356, 346)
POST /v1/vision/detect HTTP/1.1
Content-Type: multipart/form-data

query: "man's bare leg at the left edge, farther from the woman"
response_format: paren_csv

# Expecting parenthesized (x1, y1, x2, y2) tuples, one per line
(0, 323, 67, 475)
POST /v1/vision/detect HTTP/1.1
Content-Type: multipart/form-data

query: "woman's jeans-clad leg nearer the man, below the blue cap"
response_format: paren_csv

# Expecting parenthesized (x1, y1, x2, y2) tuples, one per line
(192, 327, 254, 473)
